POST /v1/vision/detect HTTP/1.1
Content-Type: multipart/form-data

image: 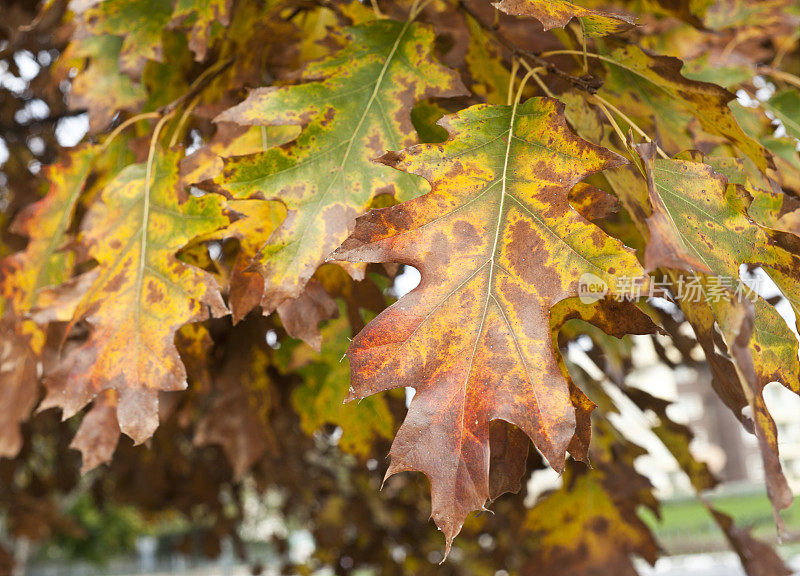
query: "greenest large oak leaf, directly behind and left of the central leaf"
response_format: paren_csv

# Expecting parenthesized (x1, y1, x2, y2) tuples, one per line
(216, 20, 463, 316)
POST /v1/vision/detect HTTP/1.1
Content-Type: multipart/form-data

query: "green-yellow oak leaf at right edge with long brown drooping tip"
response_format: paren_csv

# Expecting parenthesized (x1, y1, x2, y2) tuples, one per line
(636, 145, 800, 519)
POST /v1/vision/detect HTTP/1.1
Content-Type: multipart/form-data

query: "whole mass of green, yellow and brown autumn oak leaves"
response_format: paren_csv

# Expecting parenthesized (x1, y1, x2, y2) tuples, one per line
(0, 0, 800, 575)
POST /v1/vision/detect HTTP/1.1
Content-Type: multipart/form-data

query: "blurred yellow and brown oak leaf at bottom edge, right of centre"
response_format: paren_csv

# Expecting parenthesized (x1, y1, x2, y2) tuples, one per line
(520, 414, 659, 576)
